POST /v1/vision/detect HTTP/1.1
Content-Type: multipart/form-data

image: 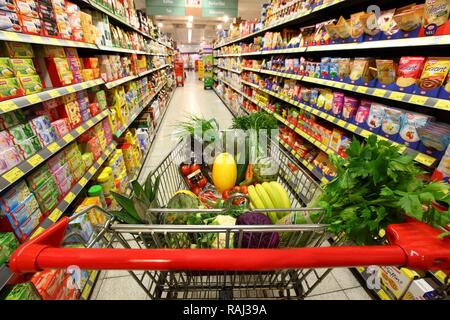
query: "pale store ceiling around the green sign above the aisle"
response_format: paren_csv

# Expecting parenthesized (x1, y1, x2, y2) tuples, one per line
(135, 0, 268, 45)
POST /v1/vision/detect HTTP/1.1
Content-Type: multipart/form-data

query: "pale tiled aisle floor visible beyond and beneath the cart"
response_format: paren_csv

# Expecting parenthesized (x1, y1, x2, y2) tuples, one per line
(91, 73, 370, 300)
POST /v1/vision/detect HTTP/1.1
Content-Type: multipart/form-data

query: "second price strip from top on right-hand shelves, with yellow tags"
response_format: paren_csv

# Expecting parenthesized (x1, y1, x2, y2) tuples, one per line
(242, 67, 450, 111)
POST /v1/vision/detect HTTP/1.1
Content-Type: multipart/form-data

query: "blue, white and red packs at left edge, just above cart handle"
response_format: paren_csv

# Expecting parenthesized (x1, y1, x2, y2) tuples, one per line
(0, 180, 42, 241)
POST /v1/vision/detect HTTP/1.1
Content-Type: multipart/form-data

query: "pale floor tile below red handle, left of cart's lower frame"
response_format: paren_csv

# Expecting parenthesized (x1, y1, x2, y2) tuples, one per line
(96, 276, 147, 300)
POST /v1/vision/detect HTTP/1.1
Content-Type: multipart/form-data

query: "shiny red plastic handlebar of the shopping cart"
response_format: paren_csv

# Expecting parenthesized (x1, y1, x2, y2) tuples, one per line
(9, 217, 450, 273)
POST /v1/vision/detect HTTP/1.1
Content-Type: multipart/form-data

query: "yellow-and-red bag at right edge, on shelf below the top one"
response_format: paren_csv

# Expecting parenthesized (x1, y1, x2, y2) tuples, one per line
(419, 57, 450, 90)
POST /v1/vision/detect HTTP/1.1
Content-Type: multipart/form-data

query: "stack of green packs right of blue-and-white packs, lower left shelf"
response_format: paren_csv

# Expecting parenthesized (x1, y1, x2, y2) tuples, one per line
(27, 165, 61, 215)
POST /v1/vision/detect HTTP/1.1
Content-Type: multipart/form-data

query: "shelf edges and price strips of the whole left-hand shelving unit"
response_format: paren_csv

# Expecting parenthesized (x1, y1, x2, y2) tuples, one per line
(0, 0, 174, 299)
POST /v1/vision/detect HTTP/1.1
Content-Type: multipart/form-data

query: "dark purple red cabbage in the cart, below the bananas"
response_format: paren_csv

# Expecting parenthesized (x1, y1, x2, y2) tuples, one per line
(234, 212, 280, 248)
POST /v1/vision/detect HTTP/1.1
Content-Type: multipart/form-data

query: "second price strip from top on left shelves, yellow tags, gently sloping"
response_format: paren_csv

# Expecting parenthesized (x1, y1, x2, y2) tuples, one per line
(0, 79, 104, 114)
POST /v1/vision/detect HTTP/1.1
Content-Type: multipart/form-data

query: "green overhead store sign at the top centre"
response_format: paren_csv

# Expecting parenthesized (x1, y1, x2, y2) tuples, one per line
(146, 0, 238, 18)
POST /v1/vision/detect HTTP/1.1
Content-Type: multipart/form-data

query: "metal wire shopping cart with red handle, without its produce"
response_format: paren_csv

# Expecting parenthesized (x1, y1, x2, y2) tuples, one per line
(10, 140, 450, 299)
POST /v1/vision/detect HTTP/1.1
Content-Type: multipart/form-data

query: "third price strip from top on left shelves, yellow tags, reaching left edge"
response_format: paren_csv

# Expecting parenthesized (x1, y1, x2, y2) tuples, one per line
(0, 110, 109, 192)
